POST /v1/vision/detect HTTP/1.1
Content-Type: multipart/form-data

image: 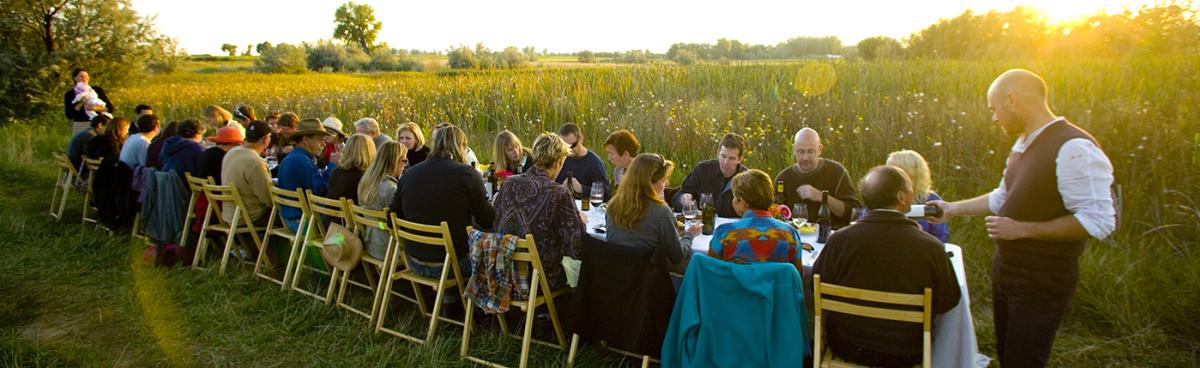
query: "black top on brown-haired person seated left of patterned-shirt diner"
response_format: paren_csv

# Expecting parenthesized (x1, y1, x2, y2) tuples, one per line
(390, 157, 496, 263)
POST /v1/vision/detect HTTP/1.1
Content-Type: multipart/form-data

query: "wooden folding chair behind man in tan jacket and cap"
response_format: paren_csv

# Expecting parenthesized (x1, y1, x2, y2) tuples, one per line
(192, 185, 263, 275)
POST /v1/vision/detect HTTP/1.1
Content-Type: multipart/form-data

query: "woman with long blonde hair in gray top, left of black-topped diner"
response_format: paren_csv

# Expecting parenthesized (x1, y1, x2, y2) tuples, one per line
(352, 141, 408, 259)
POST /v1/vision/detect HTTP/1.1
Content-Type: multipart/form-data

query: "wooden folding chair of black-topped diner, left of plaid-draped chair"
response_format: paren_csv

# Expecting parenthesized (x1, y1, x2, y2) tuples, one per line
(376, 218, 466, 344)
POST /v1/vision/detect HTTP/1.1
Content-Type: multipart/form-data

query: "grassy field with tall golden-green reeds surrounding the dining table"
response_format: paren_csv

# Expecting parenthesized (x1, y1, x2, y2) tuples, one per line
(0, 59, 1200, 367)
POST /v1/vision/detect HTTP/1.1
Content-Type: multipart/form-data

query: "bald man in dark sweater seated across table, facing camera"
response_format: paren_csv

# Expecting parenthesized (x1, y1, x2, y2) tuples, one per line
(775, 128, 862, 227)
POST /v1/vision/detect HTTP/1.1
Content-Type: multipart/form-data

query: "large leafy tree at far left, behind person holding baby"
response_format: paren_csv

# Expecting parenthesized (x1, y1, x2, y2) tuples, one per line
(0, 0, 179, 119)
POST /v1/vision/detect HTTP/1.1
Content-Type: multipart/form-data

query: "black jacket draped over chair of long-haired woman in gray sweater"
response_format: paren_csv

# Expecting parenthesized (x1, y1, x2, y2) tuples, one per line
(568, 236, 676, 357)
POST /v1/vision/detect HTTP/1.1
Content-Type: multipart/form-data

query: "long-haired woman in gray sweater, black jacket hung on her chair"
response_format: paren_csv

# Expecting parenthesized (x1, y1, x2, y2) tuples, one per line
(606, 153, 700, 269)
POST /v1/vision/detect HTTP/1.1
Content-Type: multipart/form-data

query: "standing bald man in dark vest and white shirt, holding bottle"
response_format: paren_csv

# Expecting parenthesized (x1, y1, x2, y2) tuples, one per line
(931, 70, 1116, 367)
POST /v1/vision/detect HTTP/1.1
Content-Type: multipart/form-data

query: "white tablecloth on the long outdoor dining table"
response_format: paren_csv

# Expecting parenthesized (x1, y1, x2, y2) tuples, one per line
(575, 200, 991, 368)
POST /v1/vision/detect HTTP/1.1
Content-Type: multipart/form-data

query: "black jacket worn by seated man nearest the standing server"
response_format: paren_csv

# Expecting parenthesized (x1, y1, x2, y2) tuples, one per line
(812, 210, 960, 356)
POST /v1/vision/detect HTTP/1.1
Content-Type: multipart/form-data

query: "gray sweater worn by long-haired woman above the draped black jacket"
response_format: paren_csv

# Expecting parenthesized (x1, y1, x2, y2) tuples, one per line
(605, 204, 691, 265)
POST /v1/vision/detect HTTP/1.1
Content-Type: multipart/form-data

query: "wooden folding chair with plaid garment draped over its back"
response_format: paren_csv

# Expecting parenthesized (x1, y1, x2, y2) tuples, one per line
(458, 227, 571, 368)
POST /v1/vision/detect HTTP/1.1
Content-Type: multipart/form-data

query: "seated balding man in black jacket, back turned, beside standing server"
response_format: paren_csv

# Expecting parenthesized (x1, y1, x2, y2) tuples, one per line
(812, 165, 961, 367)
